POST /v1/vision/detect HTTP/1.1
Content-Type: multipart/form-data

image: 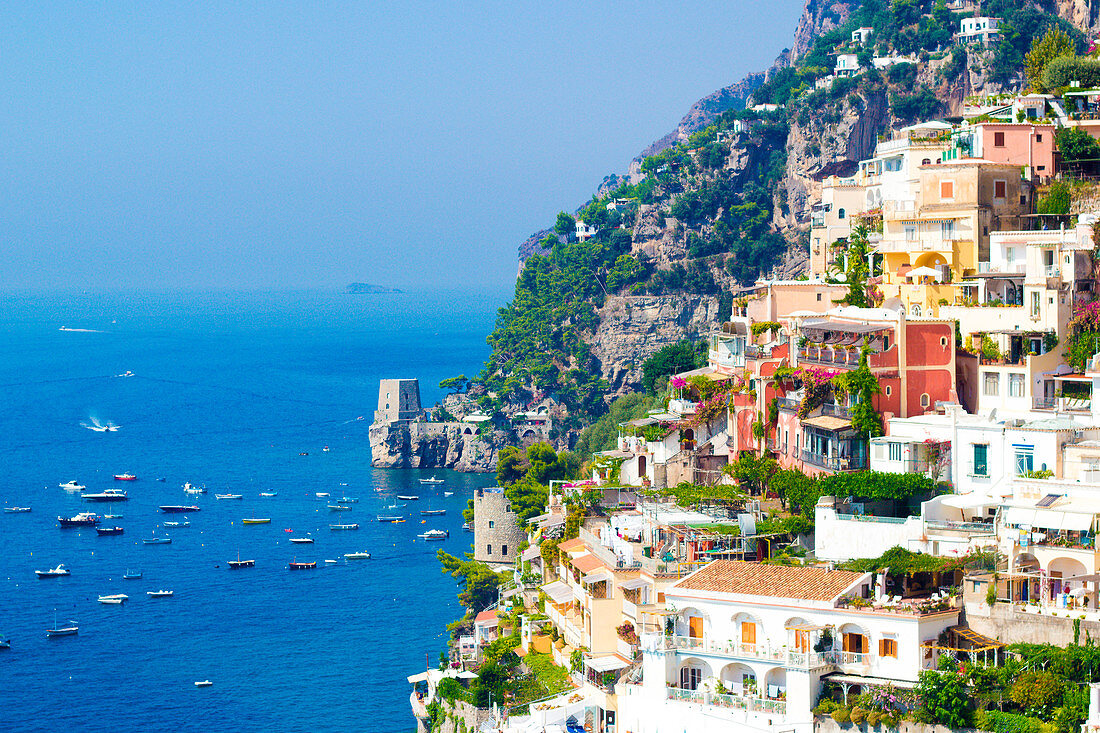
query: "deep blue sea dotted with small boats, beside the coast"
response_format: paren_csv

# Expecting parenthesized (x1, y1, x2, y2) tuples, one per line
(0, 291, 507, 732)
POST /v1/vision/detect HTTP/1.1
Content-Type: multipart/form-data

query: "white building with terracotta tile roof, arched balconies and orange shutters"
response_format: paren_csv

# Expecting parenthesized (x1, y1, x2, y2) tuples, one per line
(616, 560, 959, 733)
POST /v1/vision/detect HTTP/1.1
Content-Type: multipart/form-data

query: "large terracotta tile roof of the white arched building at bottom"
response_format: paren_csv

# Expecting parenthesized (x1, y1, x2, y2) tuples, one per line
(674, 560, 865, 601)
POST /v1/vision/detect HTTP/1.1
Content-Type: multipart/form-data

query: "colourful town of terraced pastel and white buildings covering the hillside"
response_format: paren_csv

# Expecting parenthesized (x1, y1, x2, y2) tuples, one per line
(408, 15, 1100, 733)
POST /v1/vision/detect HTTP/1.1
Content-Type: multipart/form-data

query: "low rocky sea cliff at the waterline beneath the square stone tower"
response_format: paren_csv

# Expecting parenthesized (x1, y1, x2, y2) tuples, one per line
(371, 423, 504, 473)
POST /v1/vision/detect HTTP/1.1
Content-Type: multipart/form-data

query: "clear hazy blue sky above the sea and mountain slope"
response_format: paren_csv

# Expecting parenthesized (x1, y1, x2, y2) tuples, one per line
(0, 0, 802, 289)
